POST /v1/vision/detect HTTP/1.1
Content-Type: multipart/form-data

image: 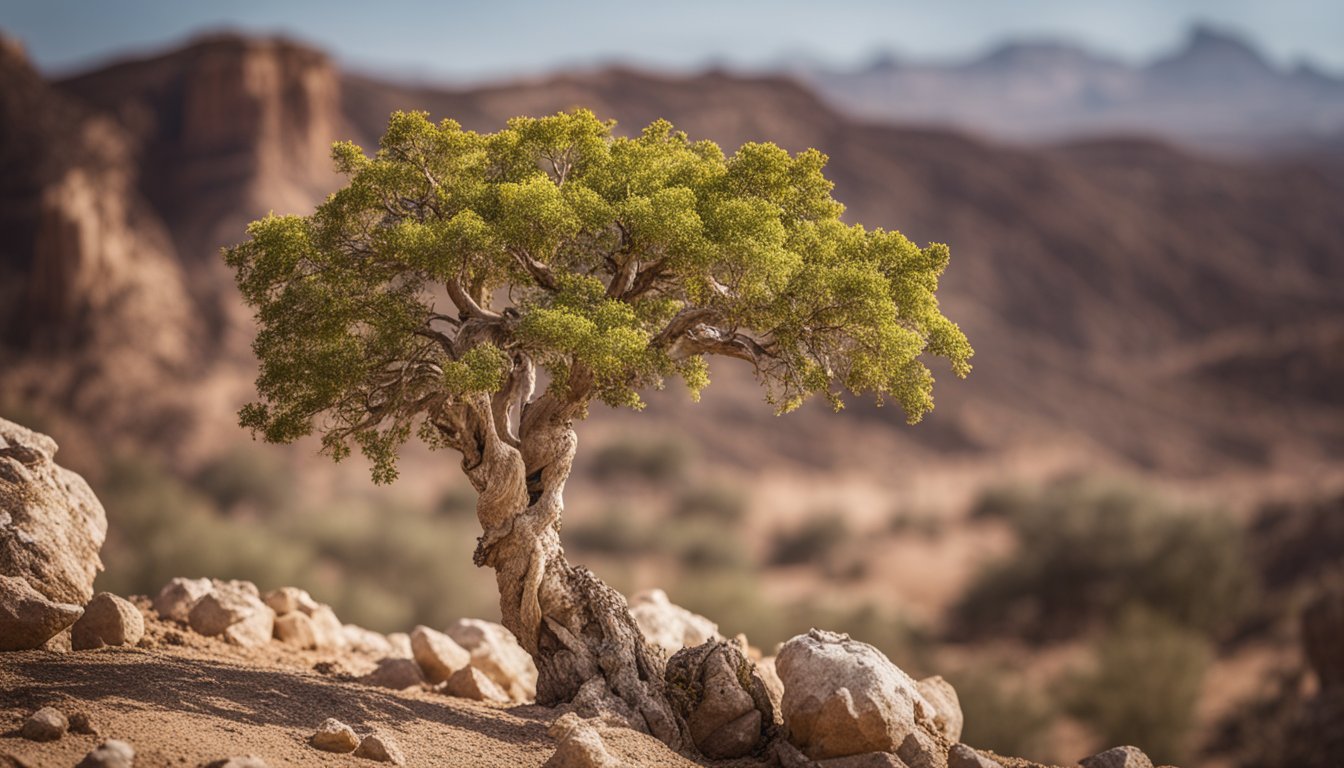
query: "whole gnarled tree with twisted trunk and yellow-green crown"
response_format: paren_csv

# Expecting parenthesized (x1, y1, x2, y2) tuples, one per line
(224, 110, 972, 745)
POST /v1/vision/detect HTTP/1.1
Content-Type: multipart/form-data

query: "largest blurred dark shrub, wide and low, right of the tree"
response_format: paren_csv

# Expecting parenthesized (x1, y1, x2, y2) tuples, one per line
(956, 480, 1255, 640)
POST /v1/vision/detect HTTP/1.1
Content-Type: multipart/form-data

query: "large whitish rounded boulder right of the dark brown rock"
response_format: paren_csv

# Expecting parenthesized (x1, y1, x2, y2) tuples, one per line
(775, 629, 934, 763)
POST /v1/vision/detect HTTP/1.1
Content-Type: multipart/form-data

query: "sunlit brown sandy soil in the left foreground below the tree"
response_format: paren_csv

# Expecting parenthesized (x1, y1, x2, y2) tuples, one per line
(0, 623, 736, 768)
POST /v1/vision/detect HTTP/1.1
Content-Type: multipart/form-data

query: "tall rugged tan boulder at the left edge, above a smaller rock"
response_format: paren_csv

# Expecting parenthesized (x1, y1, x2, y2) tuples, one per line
(0, 418, 108, 607)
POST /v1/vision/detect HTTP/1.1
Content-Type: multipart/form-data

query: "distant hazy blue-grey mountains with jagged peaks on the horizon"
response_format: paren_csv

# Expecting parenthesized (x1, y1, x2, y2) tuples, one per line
(793, 26, 1344, 153)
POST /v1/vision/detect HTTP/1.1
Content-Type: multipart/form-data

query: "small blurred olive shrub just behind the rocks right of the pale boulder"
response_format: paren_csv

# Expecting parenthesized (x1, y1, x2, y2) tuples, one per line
(946, 664, 1059, 760)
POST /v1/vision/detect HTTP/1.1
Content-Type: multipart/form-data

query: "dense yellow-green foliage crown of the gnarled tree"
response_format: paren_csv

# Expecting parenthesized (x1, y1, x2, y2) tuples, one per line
(226, 109, 972, 482)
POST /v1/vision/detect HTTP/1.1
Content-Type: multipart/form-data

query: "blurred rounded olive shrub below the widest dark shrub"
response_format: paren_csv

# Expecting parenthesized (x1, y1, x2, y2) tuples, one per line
(1062, 608, 1212, 764)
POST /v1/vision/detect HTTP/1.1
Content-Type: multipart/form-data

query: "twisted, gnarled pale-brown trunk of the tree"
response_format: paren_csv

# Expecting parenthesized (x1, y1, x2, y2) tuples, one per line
(435, 384, 689, 749)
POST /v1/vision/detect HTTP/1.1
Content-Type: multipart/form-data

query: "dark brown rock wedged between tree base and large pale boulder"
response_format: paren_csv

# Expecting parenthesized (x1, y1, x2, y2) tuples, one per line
(665, 640, 774, 760)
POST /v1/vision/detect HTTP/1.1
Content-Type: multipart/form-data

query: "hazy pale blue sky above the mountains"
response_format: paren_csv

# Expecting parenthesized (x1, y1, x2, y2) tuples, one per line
(0, 0, 1344, 79)
